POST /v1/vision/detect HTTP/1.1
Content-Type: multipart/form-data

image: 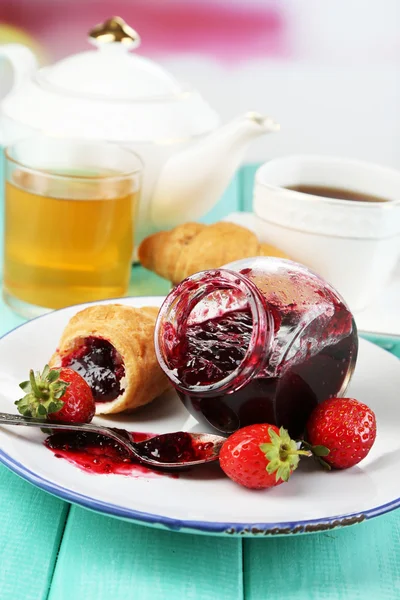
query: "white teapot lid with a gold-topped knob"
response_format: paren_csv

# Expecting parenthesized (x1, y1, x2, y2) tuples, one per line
(37, 17, 183, 100)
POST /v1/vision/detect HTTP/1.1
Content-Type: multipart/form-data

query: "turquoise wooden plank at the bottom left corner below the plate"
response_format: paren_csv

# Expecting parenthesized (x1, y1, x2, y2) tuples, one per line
(0, 465, 69, 600)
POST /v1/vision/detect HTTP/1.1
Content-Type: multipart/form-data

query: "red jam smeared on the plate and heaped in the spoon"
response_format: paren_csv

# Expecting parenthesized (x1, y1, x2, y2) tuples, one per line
(45, 429, 213, 476)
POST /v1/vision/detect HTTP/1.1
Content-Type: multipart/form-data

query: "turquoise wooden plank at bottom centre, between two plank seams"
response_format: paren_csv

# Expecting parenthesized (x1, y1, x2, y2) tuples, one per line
(49, 507, 243, 600)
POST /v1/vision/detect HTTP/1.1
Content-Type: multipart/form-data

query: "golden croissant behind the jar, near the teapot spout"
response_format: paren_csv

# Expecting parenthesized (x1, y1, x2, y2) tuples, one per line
(138, 221, 288, 284)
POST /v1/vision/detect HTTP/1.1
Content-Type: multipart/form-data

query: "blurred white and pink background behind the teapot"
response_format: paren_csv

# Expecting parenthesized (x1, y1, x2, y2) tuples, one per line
(0, 0, 400, 167)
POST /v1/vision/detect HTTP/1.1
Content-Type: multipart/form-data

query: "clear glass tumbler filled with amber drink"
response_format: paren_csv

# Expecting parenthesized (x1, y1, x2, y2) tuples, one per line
(3, 138, 141, 317)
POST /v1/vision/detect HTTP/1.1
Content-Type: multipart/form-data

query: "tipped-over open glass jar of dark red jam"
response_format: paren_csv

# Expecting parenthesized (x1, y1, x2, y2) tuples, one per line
(155, 257, 358, 438)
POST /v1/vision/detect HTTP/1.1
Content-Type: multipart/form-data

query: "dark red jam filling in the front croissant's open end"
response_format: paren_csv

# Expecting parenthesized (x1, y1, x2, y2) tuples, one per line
(61, 337, 125, 402)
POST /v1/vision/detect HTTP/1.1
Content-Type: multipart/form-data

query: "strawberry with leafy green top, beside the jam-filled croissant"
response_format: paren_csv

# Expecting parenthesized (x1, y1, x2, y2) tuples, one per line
(15, 365, 96, 423)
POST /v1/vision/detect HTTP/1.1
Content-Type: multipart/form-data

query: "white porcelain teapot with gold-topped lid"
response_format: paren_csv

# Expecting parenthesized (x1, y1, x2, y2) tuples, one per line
(0, 17, 278, 242)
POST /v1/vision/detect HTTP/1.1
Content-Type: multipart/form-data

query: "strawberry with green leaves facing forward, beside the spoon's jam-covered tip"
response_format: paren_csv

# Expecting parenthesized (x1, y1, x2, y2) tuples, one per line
(219, 424, 310, 489)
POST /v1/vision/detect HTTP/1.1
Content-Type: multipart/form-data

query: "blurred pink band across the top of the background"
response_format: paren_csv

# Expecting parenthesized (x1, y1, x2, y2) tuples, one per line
(2, 0, 290, 61)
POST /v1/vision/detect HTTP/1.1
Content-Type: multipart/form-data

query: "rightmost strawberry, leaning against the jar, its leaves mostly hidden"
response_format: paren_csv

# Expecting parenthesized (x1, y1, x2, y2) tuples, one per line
(303, 398, 376, 469)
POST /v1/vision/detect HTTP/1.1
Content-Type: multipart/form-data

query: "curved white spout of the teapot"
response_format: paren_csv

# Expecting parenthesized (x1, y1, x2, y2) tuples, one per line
(151, 113, 279, 229)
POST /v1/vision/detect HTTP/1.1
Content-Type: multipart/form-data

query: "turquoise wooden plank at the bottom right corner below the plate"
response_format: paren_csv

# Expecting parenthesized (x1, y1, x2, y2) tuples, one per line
(244, 511, 400, 600)
